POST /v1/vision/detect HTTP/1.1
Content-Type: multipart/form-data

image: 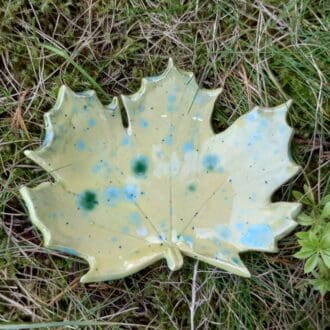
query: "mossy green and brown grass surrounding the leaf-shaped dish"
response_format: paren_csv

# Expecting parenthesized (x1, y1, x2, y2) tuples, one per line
(0, 0, 330, 329)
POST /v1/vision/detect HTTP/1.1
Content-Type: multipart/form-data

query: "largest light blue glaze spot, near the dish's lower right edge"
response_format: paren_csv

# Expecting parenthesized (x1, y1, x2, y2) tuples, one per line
(240, 224, 274, 248)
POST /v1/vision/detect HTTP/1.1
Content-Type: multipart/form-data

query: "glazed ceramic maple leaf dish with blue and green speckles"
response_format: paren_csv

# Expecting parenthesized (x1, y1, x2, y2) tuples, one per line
(20, 59, 300, 282)
